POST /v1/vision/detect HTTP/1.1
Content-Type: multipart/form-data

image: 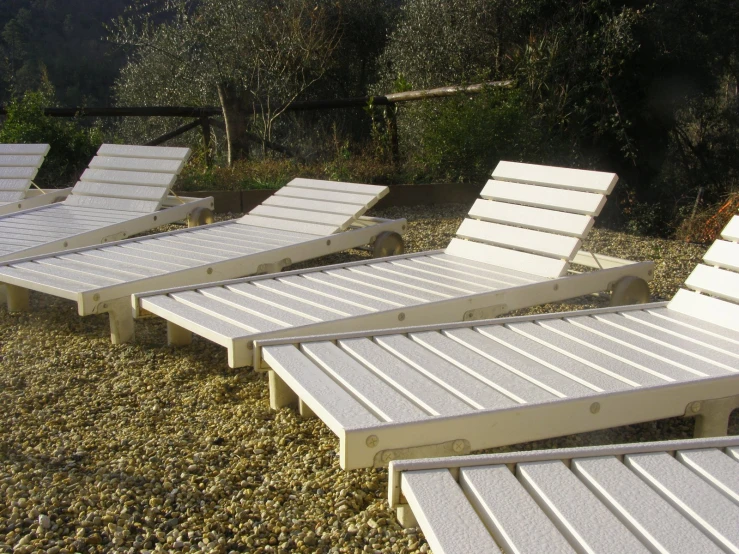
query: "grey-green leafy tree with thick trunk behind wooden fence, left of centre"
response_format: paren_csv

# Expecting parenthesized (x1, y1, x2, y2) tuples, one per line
(111, 0, 341, 165)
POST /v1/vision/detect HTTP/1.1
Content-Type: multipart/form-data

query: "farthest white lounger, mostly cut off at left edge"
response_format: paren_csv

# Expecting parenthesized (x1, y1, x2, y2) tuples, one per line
(0, 144, 72, 215)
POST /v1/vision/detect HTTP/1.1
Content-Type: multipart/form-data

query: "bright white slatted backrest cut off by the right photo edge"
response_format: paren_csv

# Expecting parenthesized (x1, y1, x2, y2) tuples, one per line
(668, 215, 739, 332)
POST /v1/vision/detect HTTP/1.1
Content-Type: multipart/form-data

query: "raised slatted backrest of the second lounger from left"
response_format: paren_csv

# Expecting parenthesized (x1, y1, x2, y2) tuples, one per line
(64, 144, 190, 213)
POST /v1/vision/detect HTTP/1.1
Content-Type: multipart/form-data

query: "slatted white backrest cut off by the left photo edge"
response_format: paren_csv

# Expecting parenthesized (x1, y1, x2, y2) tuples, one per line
(0, 144, 49, 202)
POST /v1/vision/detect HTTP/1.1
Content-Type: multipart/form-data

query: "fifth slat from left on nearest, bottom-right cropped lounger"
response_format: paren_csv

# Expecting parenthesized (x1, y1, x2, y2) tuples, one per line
(624, 452, 739, 552)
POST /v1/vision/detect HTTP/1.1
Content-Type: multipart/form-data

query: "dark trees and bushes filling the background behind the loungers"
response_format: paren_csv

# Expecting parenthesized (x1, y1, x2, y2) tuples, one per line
(0, 0, 739, 240)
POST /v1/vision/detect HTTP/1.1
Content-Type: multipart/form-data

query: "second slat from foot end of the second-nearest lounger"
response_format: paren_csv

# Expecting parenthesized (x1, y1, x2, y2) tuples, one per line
(300, 342, 428, 421)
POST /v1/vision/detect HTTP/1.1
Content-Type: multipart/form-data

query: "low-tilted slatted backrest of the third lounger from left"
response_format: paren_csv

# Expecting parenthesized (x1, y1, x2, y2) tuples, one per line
(239, 178, 389, 236)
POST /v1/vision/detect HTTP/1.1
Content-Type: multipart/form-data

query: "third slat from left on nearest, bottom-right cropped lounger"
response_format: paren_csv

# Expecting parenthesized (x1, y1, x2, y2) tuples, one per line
(516, 461, 648, 554)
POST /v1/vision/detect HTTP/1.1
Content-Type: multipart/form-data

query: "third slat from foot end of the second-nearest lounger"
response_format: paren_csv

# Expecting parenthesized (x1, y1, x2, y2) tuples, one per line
(337, 339, 474, 415)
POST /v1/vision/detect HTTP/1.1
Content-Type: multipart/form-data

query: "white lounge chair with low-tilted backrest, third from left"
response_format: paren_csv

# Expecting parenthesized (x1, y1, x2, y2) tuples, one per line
(0, 179, 406, 344)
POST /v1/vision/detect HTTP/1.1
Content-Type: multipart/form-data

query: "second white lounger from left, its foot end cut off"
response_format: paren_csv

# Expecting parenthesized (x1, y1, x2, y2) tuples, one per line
(0, 144, 213, 261)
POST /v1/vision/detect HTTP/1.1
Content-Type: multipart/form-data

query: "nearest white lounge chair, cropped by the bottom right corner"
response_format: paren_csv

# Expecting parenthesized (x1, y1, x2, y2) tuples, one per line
(389, 437, 739, 554)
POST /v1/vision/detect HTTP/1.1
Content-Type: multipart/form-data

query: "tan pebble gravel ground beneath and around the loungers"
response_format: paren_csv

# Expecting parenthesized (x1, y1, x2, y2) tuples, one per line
(0, 205, 739, 554)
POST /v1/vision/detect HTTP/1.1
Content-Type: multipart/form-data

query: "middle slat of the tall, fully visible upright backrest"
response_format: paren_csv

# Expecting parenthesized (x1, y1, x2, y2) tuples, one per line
(468, 198, 595, 238)
